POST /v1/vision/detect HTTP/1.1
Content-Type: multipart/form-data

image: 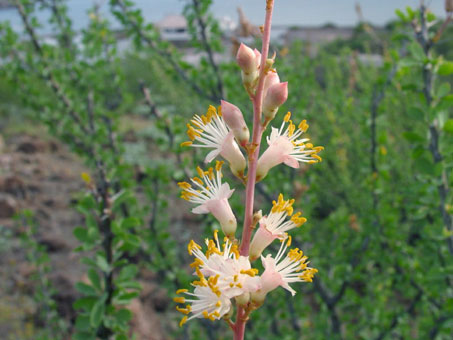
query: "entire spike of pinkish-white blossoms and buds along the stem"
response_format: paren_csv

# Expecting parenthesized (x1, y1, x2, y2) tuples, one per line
(174, 39, 323, 330)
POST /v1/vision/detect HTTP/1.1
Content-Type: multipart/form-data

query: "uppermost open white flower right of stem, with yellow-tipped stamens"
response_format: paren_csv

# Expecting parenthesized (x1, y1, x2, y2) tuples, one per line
(256, 112, 324, 181)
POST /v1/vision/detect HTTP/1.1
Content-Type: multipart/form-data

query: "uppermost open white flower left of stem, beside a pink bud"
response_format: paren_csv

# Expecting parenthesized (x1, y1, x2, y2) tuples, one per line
(181, 105, 245, 178)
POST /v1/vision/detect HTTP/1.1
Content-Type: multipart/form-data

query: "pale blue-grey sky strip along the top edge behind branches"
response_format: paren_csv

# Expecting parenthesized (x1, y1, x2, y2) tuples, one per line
(0, 0, 444, 28)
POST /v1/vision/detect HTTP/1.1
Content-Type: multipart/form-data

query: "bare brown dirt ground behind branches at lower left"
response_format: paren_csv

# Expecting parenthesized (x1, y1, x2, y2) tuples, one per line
(0, 133, 169, 340)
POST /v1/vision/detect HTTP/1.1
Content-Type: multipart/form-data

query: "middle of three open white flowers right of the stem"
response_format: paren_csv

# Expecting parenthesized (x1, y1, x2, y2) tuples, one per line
(249, 194, 307, 261)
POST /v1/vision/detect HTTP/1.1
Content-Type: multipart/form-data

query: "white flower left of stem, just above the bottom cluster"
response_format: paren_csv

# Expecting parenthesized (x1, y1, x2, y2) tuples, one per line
(178, 161, 237, 237)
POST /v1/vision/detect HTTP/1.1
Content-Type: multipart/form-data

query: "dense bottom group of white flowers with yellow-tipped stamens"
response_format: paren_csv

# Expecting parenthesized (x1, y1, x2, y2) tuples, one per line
(174, 231, 317, 326)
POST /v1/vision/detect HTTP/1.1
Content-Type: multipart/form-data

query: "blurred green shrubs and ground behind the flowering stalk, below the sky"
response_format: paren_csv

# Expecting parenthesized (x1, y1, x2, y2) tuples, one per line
(0, 0, 453, 340)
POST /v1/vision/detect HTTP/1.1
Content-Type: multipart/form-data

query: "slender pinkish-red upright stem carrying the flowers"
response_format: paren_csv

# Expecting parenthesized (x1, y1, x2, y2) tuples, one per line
(234, 0, 274, 340)
